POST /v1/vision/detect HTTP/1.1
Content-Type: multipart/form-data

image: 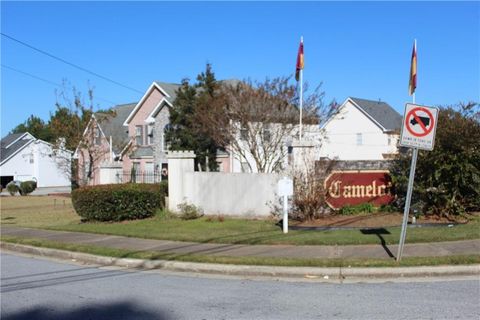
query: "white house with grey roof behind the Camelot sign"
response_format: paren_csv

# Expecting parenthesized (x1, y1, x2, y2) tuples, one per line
(320, 97, 402, 160)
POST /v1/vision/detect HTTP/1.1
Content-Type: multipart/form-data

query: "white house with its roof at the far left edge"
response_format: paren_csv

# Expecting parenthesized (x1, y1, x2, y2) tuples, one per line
(0, 132, 72, 188)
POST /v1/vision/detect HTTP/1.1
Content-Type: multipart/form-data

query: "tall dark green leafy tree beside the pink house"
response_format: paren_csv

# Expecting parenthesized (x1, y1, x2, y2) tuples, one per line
(166, 64, 218, 171)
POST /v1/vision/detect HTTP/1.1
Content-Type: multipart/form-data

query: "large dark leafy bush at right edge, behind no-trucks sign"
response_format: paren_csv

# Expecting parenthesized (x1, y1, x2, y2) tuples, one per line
(391, 102, 480, 217)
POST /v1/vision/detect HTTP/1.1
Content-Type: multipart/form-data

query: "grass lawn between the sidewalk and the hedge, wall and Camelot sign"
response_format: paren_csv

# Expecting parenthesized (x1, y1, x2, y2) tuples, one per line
(0, 196, 480, 245)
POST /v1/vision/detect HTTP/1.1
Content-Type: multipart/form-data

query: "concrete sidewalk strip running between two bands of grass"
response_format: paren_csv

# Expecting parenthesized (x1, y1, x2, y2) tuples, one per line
(1, 226, 480, 259)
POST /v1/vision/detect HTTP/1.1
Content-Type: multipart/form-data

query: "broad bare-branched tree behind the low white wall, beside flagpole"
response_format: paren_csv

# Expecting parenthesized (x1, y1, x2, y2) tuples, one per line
(196, 77, 326, 172)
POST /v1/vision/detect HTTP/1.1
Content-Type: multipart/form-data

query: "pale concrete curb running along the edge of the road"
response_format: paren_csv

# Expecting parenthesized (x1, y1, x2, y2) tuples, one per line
(0, 242, 480, 280)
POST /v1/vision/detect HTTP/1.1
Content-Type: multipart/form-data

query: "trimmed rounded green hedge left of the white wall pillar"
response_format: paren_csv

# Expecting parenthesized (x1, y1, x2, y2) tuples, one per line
(72, 183, 167, 221)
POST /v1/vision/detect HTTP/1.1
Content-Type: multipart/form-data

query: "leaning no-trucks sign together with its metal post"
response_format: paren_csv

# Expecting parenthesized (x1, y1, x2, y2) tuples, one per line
(397, 103, 438, 261)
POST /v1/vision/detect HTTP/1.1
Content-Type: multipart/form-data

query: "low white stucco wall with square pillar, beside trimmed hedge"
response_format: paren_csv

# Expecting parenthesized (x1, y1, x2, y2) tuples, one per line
(167, 151, 280, 217)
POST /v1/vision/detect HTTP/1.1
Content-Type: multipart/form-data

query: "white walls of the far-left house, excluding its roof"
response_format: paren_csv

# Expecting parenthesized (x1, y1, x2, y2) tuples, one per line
(0, 140, 71, 188)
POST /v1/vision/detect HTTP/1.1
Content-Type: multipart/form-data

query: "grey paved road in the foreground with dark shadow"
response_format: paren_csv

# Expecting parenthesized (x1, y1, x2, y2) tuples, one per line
(1, 254, 480, 320)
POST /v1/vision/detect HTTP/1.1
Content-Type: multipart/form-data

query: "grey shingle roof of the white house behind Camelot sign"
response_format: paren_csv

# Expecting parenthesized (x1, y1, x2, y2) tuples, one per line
(350, 97, 402, 131)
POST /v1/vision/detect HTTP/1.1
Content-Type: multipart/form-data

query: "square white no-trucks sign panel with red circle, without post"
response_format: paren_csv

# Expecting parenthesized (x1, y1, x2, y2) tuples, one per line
(400, 103, 438, 150)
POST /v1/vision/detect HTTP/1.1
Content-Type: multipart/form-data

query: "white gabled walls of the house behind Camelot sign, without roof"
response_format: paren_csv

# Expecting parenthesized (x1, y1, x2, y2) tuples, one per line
(320, 101, 398, 160)
